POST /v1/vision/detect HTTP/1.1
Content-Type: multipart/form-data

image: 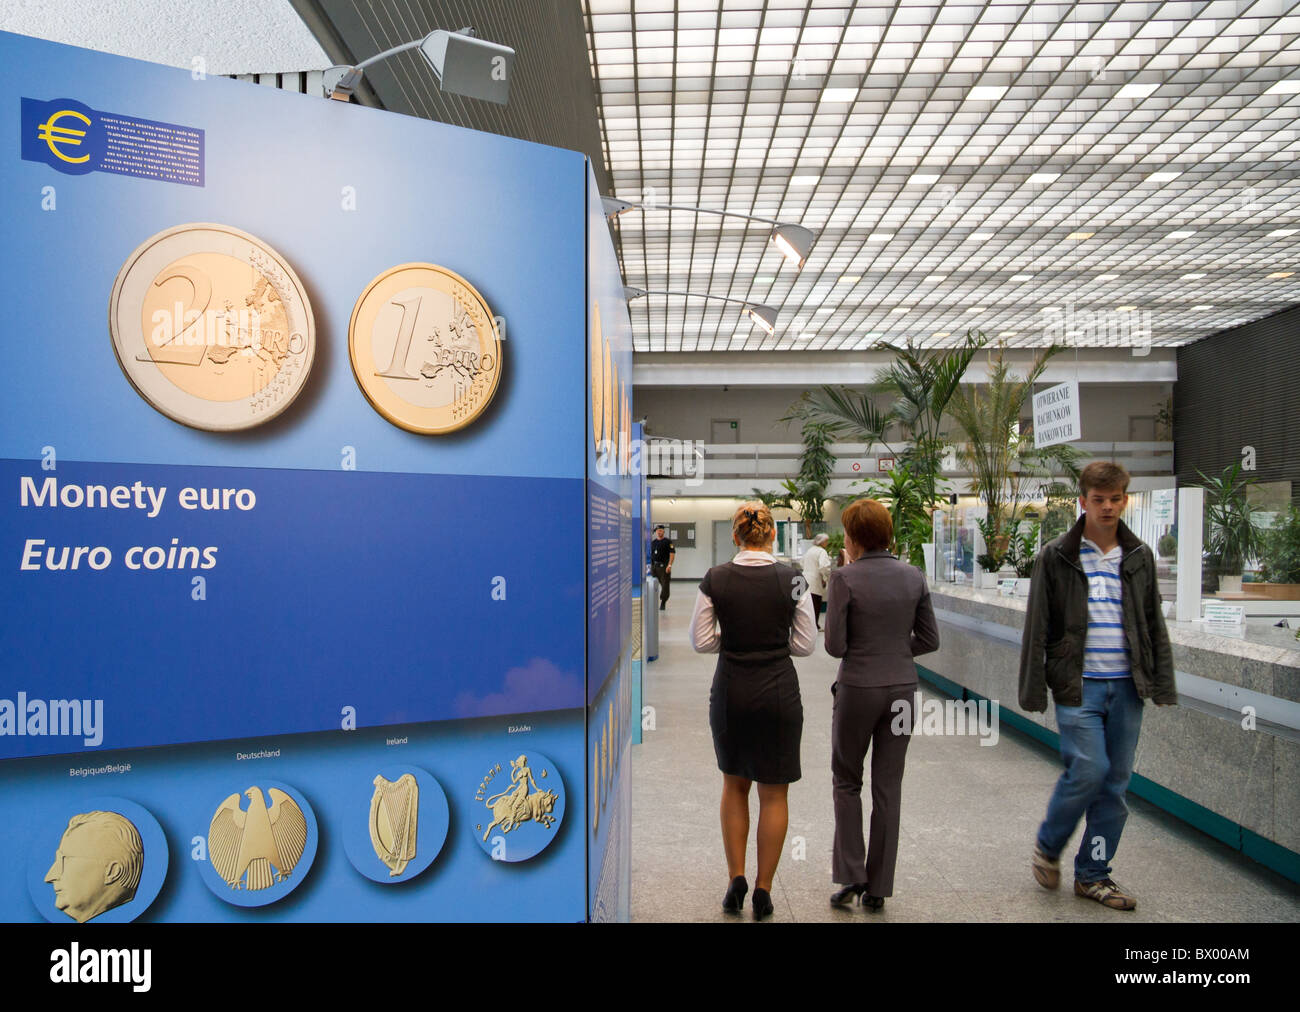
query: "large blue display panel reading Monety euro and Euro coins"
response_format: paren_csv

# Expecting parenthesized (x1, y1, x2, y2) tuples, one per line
(0, 34, 608, 920)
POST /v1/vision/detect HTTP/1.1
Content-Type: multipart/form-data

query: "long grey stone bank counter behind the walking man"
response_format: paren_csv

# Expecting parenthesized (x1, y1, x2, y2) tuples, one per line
(918, 584, 1300, 881)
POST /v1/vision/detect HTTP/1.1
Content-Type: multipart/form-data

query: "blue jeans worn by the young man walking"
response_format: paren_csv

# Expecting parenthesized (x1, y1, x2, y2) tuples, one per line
(1039, 678, 1143, 882)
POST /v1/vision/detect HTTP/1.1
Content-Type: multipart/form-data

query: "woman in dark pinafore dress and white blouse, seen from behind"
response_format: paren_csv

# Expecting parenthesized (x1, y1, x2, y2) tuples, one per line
(690, 502, 816, 920)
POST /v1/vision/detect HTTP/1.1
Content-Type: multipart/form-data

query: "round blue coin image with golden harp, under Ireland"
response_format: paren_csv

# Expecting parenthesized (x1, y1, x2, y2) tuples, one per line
(342, 766, 451, 886)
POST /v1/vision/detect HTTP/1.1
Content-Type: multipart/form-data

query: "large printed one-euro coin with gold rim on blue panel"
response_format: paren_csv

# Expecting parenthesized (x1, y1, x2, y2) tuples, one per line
(347, 264, 502, 436)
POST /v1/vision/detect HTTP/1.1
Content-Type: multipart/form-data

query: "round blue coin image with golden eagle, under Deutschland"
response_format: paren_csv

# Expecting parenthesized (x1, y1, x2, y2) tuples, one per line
(199, 780, 317, 907)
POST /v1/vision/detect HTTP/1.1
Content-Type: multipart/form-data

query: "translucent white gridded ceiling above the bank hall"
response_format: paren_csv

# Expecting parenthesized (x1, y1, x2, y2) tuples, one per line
(582, 0, 1300, 351)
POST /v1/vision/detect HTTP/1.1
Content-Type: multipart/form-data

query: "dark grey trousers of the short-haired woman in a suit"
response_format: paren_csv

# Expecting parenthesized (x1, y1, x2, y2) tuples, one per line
(831, 683, 917, 896)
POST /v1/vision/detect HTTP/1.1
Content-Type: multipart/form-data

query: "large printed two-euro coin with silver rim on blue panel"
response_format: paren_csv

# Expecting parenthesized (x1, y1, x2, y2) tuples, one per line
(108, 224, 316, 432)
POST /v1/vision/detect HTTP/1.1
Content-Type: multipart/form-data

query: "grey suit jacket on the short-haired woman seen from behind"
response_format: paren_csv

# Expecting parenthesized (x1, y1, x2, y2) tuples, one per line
(826, 552, 939, 686)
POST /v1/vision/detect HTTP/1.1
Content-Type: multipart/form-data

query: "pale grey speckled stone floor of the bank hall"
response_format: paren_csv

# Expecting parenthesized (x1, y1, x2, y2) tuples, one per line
(632, 603, 1300, 924)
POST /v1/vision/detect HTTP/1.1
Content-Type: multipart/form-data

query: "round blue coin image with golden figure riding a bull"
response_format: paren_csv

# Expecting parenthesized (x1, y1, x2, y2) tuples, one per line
(469, 749, 564, 861)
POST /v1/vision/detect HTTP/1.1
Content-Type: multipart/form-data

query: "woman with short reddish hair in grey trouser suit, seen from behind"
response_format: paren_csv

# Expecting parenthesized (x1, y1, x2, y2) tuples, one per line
(826, 499, 939, 911)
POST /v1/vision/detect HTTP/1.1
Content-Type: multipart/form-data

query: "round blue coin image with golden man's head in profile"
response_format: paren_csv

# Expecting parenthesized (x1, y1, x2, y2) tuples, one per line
(27, 797, 168, 924)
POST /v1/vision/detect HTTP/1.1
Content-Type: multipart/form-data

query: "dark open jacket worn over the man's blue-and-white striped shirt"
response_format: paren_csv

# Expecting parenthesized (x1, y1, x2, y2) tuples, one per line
(1021, 516, 1178, 713)
